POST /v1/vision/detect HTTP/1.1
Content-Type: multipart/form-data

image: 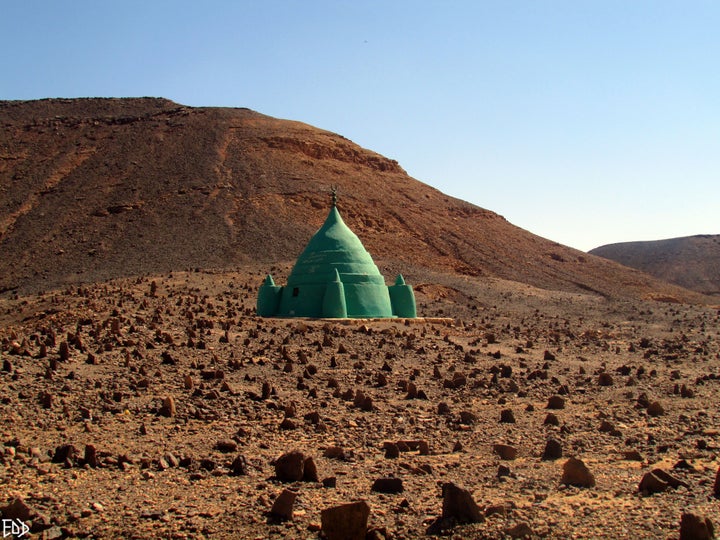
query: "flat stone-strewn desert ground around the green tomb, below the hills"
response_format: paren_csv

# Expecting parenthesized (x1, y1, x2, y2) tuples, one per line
(0, 265, 720, 539)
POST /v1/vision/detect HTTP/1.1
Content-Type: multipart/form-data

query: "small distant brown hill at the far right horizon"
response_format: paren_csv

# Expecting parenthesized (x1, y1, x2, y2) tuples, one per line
(590, 234, 720, 296)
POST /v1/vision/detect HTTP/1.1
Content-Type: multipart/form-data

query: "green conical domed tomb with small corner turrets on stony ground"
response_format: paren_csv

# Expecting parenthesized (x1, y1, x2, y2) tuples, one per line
(257, 191, 417, 319)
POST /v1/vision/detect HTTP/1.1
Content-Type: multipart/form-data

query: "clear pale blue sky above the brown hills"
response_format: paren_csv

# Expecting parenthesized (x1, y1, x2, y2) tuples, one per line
(0, 0, 720, 250)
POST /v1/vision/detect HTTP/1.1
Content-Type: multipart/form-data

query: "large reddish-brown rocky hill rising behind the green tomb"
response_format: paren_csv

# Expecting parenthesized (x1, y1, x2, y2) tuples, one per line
(0, 98, 701, 301)
